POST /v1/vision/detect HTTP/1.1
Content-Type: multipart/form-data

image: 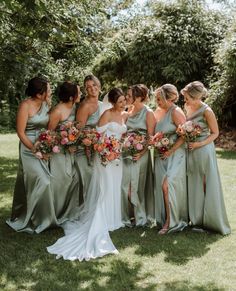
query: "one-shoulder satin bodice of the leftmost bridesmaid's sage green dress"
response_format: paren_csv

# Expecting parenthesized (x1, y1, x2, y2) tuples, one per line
(25, 102, 49, 132)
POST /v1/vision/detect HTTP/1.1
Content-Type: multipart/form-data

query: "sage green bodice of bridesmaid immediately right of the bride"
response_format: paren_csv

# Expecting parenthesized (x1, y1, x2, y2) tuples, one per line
(126, 105, 151, 131)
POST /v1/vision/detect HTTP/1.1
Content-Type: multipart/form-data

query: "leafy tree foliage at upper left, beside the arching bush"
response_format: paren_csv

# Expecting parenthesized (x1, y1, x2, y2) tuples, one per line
(0, 0, 132, 128)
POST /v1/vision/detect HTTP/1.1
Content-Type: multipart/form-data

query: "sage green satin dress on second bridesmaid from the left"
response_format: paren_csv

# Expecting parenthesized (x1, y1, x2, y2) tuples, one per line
(50, 106, 79, 223)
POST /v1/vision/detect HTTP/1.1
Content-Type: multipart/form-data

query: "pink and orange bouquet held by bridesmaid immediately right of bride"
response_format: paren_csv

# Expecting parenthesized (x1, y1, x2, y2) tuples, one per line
(122, 130, 148, 159)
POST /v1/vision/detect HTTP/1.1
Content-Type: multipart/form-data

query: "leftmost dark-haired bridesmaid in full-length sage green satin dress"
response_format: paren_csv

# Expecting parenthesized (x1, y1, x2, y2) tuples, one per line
(7, 77, 56, 233)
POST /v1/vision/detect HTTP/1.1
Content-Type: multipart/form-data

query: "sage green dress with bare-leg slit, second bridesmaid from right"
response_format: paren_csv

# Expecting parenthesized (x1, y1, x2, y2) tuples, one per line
(154, 105, 188, 233)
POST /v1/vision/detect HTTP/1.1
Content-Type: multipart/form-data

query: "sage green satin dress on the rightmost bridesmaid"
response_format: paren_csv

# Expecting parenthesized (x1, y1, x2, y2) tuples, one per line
(187, 103, 230, 235)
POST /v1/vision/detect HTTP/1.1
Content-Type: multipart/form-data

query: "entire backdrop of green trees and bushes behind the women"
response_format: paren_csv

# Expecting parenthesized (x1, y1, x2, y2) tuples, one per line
(0, 0, 236, 131)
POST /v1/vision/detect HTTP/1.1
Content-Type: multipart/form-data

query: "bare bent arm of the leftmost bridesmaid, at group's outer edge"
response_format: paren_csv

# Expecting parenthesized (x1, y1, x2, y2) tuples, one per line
(16, 101, 34, 150)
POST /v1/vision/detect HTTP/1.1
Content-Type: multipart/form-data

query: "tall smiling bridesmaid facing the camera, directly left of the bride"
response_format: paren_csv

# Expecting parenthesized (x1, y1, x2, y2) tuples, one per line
(75, 75, 102, 200)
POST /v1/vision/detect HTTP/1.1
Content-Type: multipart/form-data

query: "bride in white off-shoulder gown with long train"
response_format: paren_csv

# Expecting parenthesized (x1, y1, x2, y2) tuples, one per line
(47, 88, 128, 261)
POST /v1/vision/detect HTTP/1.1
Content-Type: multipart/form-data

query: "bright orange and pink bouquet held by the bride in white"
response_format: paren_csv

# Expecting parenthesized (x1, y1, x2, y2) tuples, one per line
(94, 135, 121, 166)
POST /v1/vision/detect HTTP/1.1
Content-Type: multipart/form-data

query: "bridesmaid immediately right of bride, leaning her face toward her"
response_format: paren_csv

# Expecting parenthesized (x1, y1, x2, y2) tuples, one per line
(121, 84, 155, 226)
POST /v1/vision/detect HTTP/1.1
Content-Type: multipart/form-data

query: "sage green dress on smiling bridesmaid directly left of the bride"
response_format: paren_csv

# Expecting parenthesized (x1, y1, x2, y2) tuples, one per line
(75, 101, 102, 201)
